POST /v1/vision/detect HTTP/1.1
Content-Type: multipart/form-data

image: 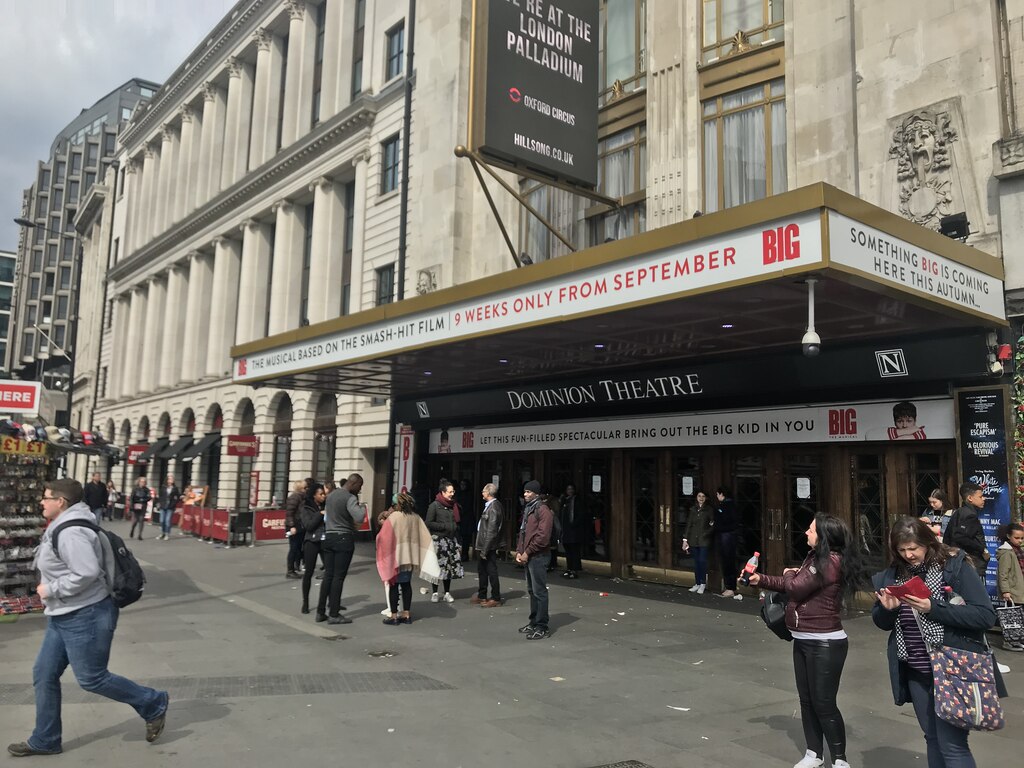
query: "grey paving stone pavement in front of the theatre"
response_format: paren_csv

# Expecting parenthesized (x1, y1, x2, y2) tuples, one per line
(0, 523, 1024, 768)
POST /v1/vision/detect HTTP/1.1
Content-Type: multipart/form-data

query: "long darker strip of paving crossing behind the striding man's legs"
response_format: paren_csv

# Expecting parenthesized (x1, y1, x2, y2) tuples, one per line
(0, 672, 454, 707)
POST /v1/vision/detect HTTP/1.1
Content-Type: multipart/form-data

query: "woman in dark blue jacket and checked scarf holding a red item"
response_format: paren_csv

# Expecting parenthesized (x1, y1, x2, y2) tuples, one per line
(871, 517, 1005, 768)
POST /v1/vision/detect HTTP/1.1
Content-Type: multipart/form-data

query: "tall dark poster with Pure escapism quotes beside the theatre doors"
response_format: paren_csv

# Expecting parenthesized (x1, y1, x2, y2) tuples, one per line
(955, 387, 1013, 595)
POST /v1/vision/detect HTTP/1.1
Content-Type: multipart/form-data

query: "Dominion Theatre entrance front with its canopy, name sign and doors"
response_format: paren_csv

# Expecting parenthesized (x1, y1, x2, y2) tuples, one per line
(231, 183, 1009, 586)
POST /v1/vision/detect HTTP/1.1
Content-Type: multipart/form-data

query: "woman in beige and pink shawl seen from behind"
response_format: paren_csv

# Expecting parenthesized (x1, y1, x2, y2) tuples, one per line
(377, 494, 440, 627)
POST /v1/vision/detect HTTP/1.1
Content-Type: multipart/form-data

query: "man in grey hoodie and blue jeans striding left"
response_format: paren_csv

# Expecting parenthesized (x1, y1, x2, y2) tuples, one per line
(7, 479, 169, 758)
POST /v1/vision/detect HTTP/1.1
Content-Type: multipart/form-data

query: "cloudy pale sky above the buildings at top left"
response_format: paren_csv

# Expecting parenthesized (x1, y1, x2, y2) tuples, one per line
(0, 0, 234, 251)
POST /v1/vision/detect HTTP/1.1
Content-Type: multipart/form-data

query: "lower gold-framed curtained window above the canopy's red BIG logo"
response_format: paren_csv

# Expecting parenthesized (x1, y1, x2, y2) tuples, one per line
(702, 78, 787, 213)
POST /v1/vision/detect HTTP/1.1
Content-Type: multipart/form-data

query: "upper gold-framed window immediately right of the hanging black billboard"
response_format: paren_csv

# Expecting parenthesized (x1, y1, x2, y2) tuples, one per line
(598, 0, 647, 103)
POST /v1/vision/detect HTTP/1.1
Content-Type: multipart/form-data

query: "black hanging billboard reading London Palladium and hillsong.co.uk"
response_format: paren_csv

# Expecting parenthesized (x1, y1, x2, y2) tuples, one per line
(470, 0, 599, 187)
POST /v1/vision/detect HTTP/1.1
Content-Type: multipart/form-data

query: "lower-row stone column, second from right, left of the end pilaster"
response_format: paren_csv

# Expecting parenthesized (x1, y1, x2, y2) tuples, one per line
(307, 176, 345, 323)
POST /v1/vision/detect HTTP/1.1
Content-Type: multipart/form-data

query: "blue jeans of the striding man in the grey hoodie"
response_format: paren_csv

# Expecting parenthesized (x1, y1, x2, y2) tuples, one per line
(29, 598, 167, 752)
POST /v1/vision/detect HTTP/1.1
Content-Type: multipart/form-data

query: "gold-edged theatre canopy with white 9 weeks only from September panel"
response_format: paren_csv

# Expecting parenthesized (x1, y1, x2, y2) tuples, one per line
(231, 183, 1007, 399)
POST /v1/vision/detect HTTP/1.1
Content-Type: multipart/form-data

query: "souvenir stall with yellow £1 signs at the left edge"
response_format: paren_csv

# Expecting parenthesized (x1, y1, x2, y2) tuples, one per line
(0, 437, 56, 616)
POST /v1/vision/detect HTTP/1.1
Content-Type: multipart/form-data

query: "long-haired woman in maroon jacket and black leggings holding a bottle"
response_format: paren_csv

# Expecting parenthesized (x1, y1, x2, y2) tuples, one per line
(751, 512, 861, 768)
